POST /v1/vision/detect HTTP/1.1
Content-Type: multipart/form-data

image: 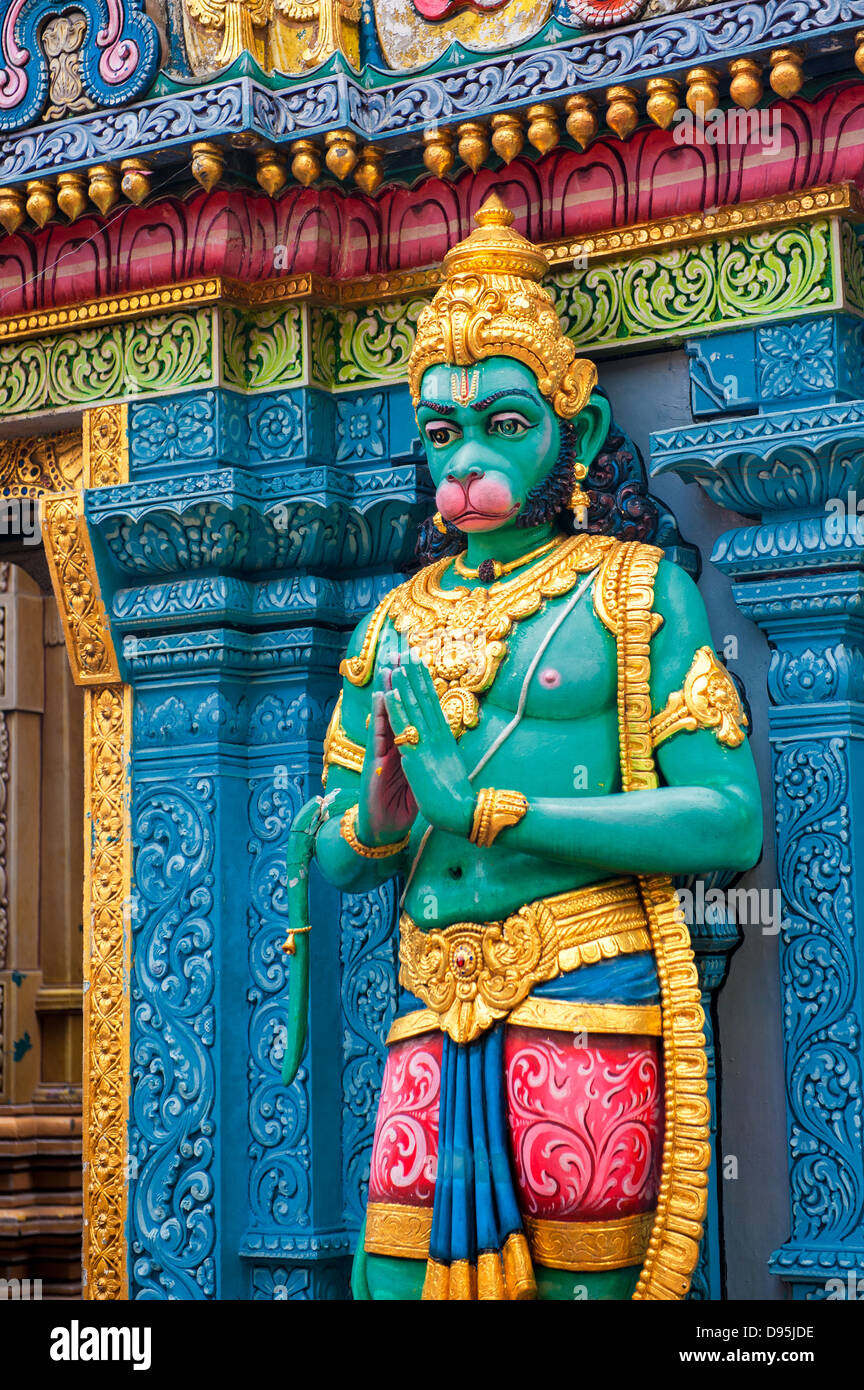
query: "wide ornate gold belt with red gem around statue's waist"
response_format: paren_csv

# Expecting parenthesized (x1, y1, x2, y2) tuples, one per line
(399, 878, 651, 1043)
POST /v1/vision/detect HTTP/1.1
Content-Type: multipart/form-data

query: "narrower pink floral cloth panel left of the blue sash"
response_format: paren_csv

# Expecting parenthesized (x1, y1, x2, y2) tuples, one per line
(369, 1033, 443, 1207)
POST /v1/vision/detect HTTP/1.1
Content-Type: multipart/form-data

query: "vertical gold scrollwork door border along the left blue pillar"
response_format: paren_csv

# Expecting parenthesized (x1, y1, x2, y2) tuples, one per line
(42, 406, 132, 1300)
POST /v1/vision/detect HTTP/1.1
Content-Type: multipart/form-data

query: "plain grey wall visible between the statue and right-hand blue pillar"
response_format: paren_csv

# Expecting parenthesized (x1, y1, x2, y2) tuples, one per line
(599, 350, 789, 1300)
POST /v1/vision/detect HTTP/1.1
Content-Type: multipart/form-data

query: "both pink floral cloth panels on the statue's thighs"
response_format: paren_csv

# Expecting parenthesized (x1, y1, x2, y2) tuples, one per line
(369, 1027, 664, 1220)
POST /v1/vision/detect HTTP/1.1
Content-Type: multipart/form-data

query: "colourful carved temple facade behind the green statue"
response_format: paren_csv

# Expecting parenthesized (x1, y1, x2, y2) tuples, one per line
(0, 0, 864, 1300)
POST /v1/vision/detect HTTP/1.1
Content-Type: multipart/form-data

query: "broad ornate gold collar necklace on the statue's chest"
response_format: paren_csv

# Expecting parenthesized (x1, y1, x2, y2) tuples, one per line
(388, 534, 617, 738)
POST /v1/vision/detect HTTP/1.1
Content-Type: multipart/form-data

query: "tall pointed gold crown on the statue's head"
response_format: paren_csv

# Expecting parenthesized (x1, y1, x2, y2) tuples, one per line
(408, 193, 597, 420)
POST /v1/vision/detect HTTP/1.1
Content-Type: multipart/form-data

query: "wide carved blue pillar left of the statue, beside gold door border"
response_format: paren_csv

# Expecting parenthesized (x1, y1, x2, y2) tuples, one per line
(86, 388, 428, 1300)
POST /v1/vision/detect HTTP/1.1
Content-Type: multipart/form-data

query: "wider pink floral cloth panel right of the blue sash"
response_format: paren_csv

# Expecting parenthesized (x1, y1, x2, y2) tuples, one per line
(504, 1027, 664, 1220)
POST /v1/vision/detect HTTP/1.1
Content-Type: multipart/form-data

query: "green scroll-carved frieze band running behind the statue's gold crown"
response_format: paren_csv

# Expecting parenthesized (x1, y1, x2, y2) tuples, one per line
(0, 217, 864, 418)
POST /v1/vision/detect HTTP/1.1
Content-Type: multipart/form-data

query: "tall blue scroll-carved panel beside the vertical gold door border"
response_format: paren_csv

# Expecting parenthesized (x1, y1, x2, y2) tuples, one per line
(129, 778, 218, 1298)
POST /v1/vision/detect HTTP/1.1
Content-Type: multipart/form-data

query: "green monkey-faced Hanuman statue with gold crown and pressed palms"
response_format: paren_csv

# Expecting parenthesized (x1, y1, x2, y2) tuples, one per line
(280, 196, 761, 1300)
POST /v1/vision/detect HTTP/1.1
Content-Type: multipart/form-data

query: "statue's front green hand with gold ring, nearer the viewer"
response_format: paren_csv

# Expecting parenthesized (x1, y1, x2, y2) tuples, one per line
(385, 657, 475, 835)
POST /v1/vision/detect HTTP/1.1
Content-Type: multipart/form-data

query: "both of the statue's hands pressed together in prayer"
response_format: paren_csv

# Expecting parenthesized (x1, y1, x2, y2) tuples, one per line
(357, 656, 475, 844)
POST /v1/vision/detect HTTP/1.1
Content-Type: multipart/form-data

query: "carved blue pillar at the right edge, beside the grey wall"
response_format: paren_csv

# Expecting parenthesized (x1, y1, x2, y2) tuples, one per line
(651, 316, 864, 1298)
